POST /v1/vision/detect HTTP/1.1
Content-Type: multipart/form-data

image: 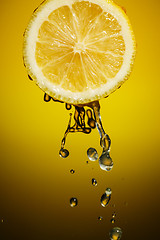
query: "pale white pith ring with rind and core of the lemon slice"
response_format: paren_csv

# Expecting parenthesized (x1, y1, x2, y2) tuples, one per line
(24, 0, 135, 103)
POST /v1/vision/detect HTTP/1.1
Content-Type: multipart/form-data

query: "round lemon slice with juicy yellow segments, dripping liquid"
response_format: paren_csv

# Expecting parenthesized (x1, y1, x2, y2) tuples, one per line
(24, 0, 136, 104)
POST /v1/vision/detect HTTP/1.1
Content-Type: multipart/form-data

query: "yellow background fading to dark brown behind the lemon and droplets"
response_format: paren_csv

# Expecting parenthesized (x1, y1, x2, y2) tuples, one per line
(0, 0, 160, 240)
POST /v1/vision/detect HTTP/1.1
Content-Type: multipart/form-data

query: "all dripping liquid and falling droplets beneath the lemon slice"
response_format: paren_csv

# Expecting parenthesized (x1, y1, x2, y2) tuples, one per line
(42, 94, 122, 240)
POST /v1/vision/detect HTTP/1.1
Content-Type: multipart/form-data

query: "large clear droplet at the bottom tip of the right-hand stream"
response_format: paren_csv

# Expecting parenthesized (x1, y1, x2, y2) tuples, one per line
(99, 152, 113, 171)
